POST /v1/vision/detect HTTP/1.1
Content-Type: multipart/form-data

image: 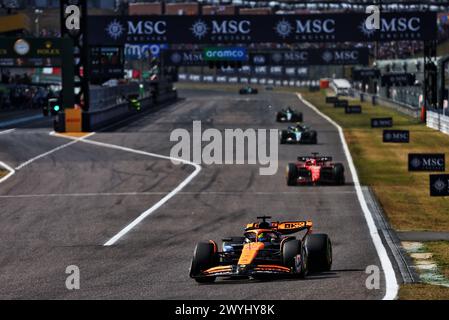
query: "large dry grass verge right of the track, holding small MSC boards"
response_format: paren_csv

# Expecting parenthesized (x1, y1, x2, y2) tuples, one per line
(303, 91, 449, 231)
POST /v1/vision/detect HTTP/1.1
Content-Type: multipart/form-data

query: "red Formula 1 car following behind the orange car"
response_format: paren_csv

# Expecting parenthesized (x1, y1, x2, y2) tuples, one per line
(286, 153, 345, 186)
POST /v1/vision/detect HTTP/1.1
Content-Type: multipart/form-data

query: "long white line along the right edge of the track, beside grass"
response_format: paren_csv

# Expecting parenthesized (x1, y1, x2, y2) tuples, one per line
(297, 94, 399, 300)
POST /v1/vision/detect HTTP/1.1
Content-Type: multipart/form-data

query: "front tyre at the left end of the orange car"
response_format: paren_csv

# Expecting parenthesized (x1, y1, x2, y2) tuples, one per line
(190, 242, 218, 283)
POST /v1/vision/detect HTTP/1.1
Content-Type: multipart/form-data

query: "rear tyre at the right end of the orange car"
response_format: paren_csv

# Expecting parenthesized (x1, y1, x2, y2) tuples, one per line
(305, 233, 332, 272)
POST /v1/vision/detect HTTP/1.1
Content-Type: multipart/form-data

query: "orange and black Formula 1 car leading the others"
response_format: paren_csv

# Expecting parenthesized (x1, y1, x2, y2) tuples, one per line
(190, 217, 332, 283)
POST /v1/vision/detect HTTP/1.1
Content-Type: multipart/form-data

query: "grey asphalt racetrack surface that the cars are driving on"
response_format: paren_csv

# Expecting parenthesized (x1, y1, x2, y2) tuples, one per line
(0, 89, 397, 300)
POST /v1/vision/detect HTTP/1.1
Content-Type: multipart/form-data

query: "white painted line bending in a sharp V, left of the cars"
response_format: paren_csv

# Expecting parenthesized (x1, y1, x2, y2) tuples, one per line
(50, 134, 201, 247)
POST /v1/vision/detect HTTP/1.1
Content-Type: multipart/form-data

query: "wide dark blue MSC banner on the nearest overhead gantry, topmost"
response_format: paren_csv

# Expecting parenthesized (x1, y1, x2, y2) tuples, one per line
(88, 12, 437, 46)
